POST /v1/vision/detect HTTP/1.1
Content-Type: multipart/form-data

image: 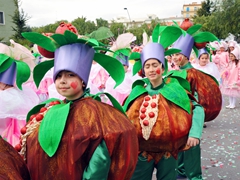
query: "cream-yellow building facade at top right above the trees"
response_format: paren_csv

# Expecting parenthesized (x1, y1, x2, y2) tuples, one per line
(181, 2, 202, 19)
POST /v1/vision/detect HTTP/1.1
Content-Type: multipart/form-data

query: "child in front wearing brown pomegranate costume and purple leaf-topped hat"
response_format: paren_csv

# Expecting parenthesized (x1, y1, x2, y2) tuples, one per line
(20, 31, 138, 180)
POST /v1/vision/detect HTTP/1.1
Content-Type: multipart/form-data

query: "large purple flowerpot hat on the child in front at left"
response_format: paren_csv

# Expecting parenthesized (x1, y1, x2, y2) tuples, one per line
(53, 43, 95, 86)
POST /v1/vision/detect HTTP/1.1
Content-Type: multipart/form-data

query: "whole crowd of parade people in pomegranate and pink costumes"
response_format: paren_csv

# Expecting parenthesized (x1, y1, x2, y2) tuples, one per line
(0, 19, 240, 180)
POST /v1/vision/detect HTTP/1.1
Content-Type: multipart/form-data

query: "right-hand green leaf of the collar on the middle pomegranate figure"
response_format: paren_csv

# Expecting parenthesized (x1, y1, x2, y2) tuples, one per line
(159, 78, 191, 114)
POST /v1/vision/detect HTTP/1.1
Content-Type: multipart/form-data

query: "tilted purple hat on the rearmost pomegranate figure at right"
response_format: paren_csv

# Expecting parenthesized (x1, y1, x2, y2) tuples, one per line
(173, 34, 194, 59)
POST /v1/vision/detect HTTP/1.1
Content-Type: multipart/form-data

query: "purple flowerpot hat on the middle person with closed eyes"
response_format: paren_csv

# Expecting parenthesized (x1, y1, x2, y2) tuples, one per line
(141, 42, 165, 73)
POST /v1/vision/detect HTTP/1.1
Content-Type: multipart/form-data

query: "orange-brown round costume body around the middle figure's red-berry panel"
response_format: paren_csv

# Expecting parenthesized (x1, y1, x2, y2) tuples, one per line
(127, 94, 192, 161)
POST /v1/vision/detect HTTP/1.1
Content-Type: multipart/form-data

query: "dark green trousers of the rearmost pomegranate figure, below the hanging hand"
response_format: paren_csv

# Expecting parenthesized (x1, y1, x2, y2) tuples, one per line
(178, 145, 202, 180)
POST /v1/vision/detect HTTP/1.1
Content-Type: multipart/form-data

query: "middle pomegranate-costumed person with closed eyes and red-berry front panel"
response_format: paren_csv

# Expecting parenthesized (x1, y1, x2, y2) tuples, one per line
(124, 42, 197, 180)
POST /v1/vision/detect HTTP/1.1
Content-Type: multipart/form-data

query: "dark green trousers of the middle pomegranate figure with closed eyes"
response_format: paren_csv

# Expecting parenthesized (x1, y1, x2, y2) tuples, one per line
(131, 154, 177, 180)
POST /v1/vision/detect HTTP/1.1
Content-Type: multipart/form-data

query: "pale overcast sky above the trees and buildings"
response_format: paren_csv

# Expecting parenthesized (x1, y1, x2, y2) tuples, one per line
(20, 0, 202, 27)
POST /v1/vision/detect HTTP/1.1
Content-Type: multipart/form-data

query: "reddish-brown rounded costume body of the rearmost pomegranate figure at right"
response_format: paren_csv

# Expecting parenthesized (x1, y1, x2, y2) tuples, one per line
(187, 68, 222, 122)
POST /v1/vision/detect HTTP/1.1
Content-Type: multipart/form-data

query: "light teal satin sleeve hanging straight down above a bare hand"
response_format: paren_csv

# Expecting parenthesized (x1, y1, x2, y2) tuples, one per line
(189, 93, 205, 139)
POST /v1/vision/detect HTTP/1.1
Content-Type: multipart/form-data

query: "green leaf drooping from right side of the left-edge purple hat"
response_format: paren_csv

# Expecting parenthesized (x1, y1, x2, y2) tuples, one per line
(15, 61, 31, 90)
